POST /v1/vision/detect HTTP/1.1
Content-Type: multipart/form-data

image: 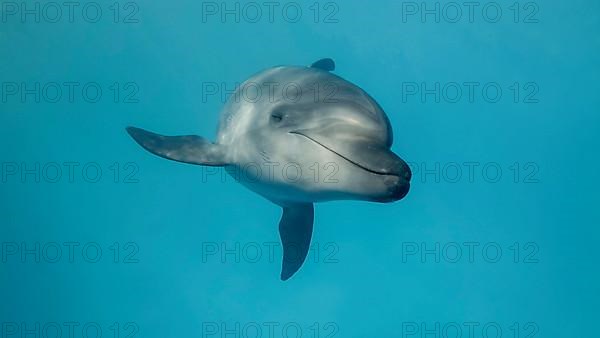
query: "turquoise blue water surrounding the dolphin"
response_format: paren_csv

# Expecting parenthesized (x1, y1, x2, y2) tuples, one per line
(0, 0, 600, 337)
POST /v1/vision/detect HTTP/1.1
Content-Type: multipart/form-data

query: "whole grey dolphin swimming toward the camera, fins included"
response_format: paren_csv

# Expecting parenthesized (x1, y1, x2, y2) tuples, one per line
(127, 59, 411, 280)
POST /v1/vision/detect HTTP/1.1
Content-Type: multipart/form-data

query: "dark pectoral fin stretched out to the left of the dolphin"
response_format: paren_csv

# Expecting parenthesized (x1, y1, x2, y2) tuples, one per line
(127, 127, 227, 166)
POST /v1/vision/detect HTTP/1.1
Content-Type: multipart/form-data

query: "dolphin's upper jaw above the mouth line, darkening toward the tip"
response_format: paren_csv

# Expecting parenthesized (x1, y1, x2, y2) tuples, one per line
(290, 129, 412, 183)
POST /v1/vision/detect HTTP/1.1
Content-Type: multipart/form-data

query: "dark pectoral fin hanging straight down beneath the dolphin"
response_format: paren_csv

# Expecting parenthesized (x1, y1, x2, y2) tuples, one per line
(279, 203, 315, 281)
